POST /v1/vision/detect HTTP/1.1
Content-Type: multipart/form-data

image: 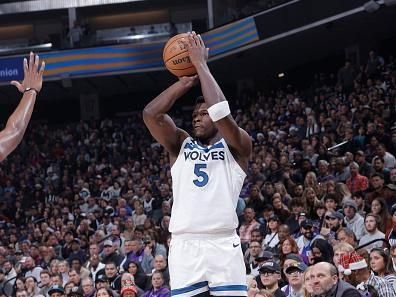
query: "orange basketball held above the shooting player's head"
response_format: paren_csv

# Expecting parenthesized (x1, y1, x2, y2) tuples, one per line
(162, 33, 197, 77)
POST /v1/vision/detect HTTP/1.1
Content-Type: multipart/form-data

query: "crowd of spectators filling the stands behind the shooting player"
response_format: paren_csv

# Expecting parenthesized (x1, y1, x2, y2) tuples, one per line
(0, 52, 396, 297)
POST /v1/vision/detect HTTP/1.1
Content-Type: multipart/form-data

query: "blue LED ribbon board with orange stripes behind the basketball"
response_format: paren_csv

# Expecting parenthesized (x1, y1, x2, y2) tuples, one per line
(0, 17, 259, 81)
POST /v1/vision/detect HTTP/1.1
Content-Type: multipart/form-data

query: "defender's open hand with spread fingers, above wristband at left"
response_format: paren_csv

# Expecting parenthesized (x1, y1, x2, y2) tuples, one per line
(11, 52, 45, 93)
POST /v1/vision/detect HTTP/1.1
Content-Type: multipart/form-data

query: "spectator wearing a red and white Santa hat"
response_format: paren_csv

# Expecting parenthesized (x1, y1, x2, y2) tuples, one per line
(341, 252, 396, 297)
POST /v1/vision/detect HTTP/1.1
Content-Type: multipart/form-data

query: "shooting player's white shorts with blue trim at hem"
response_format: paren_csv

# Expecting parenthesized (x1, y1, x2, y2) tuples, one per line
(169, 233, 247, 297)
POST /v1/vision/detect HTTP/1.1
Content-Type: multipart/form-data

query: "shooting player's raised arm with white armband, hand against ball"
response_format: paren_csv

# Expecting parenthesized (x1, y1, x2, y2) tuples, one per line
(187, 32, 252, 166)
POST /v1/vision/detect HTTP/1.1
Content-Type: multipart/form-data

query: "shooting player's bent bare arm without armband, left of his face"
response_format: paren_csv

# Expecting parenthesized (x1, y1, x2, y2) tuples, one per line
(143, 76, 198, 157)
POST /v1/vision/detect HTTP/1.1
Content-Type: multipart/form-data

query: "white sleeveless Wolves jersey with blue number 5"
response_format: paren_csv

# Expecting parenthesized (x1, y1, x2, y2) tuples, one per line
(169, 137, 246, 234)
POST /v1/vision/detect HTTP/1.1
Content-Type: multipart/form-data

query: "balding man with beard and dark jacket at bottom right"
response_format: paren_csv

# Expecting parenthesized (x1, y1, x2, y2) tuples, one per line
(309, 262, 361, 297)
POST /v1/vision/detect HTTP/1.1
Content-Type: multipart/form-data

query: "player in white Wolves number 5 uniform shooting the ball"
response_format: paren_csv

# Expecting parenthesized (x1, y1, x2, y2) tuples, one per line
(143, 32, 252, 297)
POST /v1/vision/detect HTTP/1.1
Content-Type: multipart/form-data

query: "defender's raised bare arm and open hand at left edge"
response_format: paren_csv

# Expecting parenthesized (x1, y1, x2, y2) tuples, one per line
(0, 53, 45, 161)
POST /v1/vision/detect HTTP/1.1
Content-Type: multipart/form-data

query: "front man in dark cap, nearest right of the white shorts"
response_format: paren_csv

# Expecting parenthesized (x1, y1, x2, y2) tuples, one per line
(259, 261, 286, 297)
